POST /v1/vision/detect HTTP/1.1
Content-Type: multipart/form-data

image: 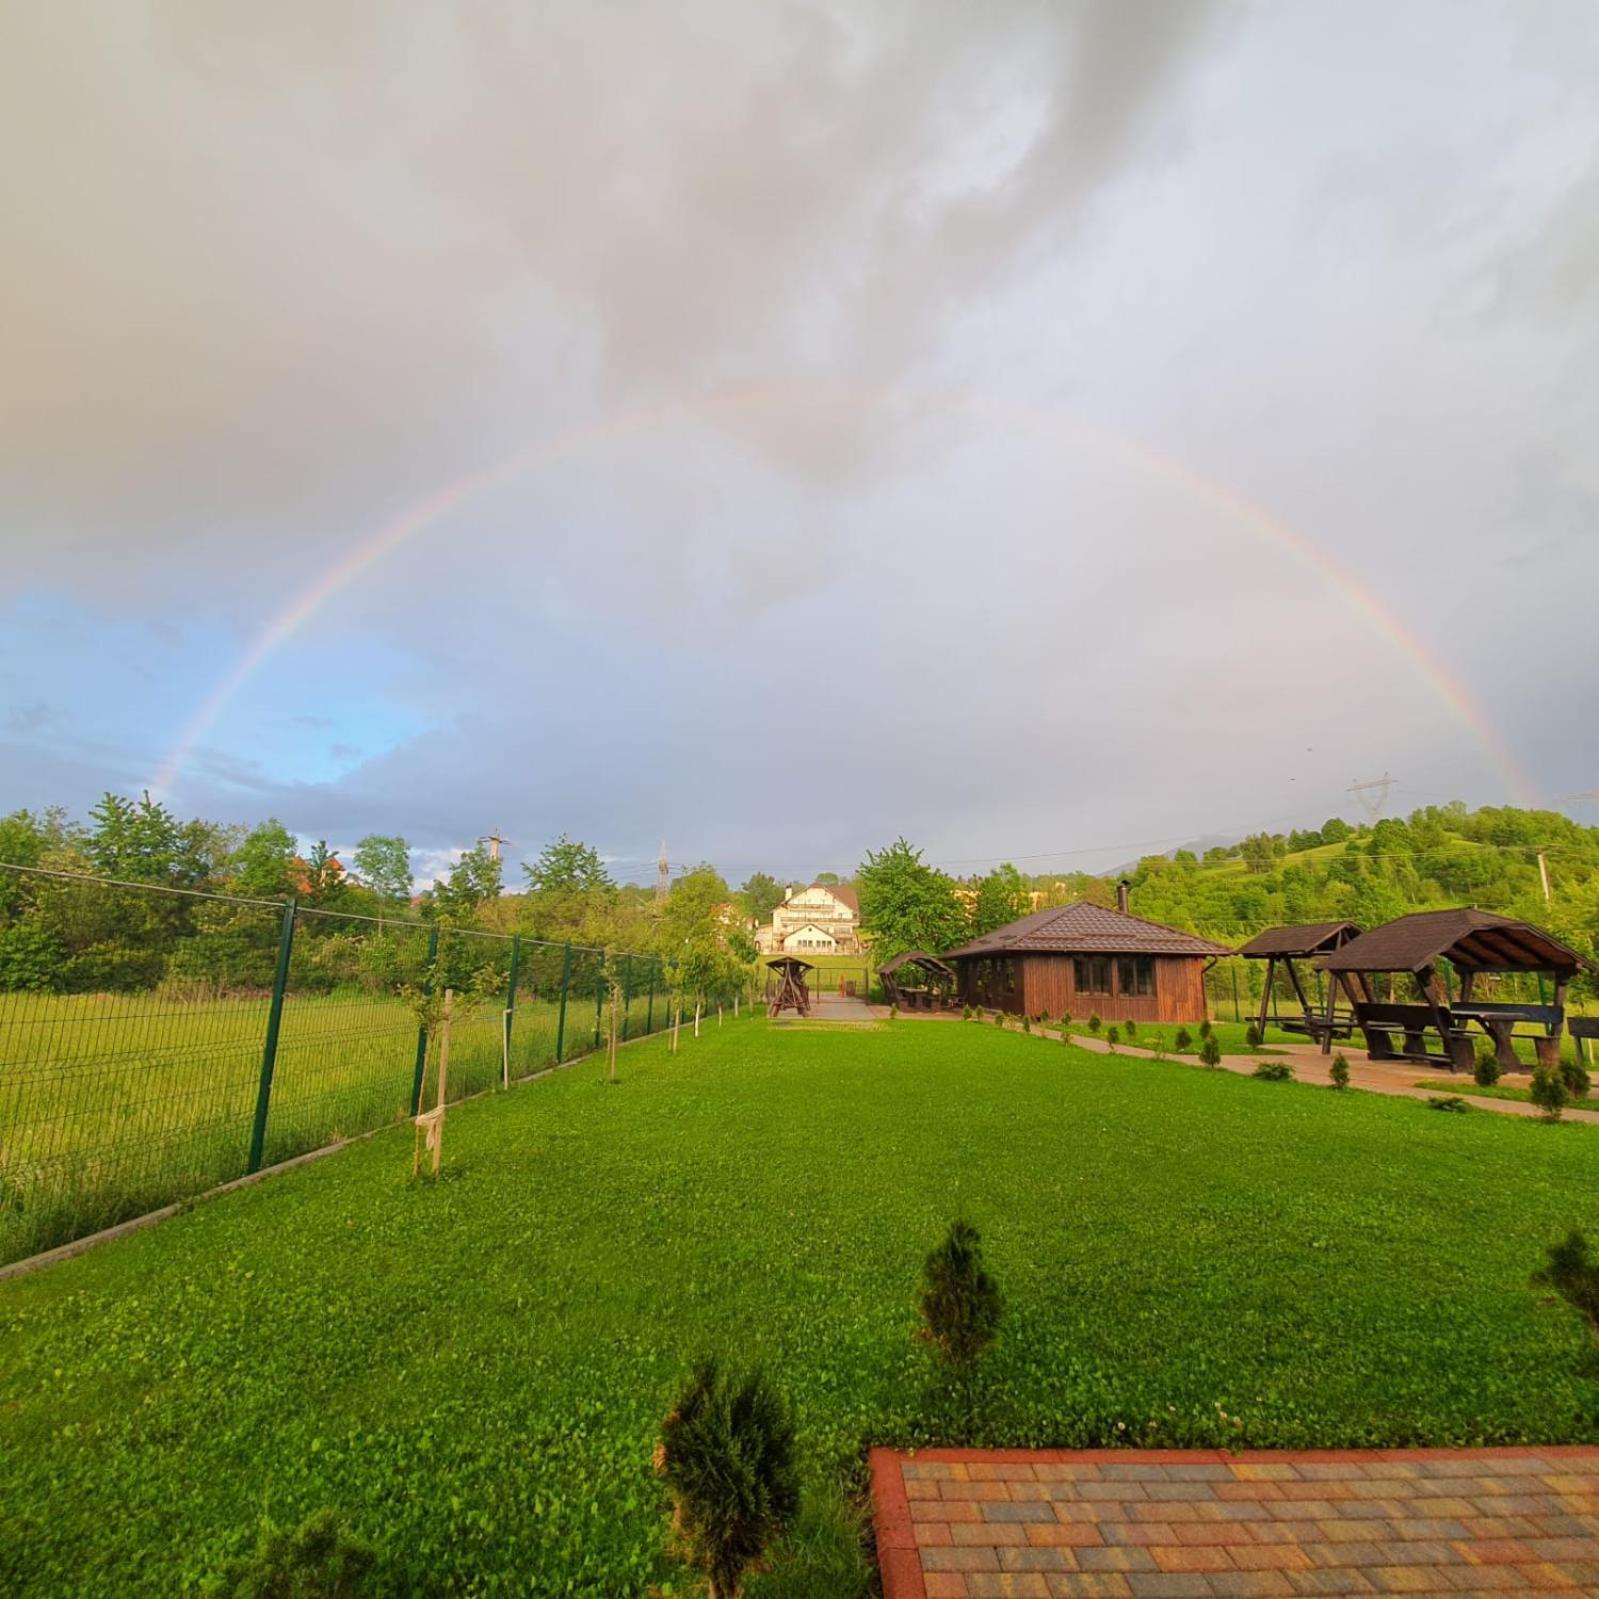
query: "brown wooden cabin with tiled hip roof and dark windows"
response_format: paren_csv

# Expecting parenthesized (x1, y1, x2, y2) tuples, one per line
(943, 887, 1233, 1022)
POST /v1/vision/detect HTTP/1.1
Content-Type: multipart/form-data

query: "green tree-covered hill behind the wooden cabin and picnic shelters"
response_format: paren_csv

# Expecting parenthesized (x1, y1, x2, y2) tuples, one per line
(1031, 803, 1599, 956)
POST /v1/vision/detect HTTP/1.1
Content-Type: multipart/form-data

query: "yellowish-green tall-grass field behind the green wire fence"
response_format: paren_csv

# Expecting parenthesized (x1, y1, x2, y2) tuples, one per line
(0, 991, 665, 1262)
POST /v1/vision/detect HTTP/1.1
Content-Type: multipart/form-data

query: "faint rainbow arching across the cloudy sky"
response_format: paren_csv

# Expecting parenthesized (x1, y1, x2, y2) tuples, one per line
(149, 381, 1538, 806)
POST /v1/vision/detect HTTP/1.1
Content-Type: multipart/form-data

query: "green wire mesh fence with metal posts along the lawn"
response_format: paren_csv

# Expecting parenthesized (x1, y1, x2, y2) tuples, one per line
(0, 867, 687, 1263)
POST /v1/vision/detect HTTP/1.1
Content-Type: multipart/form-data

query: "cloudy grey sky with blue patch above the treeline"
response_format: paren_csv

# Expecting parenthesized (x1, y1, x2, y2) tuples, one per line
(0, 0, 1599, 881)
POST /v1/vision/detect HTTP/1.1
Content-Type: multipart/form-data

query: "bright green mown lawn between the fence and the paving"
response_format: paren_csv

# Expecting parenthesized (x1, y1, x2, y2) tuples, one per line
(0, 1020, 1599, 1599)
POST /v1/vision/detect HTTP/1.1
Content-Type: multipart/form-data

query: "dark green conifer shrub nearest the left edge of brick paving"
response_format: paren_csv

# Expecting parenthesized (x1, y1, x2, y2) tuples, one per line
(656, 1359, 800, 1599)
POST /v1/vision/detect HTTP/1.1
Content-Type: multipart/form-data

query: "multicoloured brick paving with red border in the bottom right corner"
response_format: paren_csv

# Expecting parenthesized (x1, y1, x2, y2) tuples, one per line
(871, 1447, 1599, 1599)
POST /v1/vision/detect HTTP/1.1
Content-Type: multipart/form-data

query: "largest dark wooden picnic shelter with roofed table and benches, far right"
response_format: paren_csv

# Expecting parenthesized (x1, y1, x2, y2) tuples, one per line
(1318, 910, 1591, 1071)
